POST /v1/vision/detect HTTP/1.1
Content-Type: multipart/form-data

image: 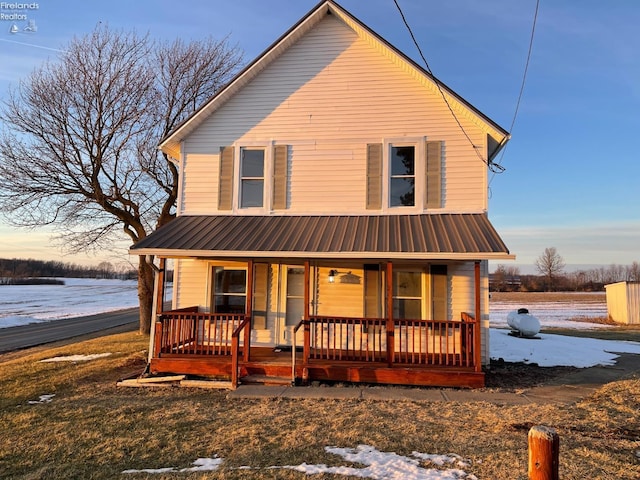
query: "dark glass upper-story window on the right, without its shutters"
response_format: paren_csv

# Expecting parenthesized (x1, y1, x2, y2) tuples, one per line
(389, 145, 416, 207)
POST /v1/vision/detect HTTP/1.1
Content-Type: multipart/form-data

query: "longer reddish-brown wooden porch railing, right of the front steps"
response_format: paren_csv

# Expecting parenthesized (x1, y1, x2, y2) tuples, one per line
(305, 313, 480, 367)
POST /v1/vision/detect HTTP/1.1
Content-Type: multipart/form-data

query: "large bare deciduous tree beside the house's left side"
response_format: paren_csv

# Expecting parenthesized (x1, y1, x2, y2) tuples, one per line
(0, 26, 242, 333)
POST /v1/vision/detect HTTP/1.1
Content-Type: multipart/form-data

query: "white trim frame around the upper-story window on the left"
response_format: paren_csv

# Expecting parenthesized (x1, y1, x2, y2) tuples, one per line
(233, 140, 275, 215)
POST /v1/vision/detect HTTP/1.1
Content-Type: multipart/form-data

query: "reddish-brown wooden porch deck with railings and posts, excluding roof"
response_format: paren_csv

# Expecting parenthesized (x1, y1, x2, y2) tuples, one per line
(150, 259, 484, 388)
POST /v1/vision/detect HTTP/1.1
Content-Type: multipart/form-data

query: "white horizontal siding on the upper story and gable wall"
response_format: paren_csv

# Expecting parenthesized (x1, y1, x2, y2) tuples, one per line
(180, 16, 487, 214)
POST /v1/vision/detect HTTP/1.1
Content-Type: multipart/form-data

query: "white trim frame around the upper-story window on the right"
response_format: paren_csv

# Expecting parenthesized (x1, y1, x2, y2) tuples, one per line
(382, 137, 426, 213)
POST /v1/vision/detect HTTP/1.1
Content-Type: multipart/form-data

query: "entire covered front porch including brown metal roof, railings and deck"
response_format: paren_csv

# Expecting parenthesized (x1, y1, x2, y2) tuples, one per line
(131, 213, 513, 387)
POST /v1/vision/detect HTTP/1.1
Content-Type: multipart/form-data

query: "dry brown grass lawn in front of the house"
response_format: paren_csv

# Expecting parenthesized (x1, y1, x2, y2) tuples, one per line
(0, 334, 640, 480)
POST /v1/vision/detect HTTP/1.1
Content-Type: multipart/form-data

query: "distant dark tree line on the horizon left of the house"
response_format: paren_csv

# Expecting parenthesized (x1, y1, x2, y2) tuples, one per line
(0, 258, 138, 284)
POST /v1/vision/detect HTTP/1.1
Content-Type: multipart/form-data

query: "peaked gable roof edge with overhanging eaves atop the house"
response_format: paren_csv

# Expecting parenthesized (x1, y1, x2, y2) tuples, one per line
(159, 0, 509, 161)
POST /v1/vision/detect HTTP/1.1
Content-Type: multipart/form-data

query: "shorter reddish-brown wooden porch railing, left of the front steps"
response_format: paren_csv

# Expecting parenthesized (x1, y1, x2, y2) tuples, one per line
(155, 307, 249, 357)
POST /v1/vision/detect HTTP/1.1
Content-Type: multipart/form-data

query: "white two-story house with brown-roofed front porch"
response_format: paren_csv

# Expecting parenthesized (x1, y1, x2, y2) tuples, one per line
(131, 0, 513, 387)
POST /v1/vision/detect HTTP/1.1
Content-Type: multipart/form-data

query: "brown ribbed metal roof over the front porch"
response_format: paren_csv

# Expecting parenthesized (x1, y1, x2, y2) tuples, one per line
(131, 214, 512, 259)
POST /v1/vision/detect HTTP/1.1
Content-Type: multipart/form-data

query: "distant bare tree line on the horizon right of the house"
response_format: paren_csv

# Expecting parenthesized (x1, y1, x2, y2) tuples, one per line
(489, 262, 640, 292)
